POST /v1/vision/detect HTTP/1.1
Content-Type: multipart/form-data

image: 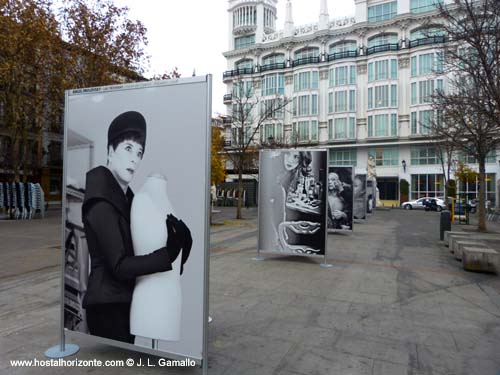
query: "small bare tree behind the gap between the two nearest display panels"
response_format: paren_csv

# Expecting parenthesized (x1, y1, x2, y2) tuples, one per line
(227, 78, 291, 219)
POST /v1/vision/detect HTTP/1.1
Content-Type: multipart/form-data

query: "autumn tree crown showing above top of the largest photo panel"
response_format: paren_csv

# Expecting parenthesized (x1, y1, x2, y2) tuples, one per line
(59, 0, 149, 88)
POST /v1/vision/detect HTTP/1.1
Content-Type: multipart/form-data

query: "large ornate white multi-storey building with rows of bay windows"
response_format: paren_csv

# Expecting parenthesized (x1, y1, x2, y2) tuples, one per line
(223, 0, 500, 206)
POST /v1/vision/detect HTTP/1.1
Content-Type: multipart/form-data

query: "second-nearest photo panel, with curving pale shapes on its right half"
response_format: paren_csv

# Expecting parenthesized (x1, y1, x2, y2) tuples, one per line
(258, 149, 327, 255)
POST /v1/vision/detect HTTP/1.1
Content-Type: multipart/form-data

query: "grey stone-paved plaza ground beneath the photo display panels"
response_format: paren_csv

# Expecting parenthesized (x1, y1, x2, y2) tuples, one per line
(0, 208, 500, 375)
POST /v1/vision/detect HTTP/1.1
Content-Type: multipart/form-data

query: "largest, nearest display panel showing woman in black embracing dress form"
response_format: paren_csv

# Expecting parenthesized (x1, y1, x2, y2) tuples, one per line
(63, 76, 211, 364)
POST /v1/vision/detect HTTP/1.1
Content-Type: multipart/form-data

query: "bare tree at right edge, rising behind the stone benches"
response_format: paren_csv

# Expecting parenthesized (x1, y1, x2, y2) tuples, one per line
(433, 0, 500, 231)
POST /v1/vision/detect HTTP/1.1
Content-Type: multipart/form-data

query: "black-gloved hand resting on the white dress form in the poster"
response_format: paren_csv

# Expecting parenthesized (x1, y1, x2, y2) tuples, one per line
(166, 214, 193, 275)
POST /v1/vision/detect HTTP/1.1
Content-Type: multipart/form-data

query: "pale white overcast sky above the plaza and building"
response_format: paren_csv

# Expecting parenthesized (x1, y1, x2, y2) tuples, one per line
(115, 0, 354, 115)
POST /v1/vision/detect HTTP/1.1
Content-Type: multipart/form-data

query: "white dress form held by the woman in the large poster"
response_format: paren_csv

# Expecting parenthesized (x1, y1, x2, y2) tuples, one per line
(130, 175, 182, 341)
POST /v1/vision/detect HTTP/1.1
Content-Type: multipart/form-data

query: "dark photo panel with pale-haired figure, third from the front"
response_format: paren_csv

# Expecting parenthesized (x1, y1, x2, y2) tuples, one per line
(327, 166, 353, 231)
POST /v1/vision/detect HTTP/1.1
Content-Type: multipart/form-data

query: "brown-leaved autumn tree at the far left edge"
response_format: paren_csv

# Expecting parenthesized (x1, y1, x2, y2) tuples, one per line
(0, 0, 65, 180)
